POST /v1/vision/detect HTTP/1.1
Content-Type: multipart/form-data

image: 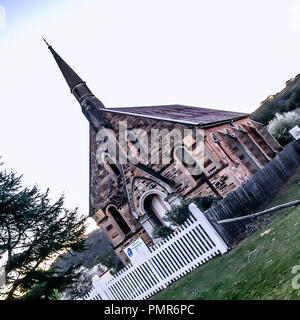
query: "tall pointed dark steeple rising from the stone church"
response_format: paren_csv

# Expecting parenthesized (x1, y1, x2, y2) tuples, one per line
(43, 38, 110, 131)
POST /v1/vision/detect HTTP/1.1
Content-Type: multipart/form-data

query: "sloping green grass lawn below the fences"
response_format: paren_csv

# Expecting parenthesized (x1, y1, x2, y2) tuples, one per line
(151, 169, 300, 300)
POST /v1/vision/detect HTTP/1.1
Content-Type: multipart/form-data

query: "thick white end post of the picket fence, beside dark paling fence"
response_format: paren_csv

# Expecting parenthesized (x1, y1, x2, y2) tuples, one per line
(189, 203, 228, 254)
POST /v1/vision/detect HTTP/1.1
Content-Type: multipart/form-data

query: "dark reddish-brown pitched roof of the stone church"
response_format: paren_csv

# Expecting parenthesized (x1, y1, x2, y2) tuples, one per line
(103, 104, 248, 127)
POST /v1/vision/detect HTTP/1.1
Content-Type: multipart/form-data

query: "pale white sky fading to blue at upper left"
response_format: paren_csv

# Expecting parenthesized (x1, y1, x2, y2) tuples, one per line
(0, 0, 300, 234)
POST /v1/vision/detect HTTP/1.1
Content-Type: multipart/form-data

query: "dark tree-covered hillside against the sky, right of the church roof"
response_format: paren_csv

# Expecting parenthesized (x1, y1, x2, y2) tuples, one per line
(251, 74, 300, 125)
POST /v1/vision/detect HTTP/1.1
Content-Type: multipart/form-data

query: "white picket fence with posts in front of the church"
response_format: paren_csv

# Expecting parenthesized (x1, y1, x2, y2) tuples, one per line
(79, 204, 228, 300)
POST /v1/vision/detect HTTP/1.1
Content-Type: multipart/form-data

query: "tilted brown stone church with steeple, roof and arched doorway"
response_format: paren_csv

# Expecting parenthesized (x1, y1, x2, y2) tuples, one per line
(48, 40, 281, 264)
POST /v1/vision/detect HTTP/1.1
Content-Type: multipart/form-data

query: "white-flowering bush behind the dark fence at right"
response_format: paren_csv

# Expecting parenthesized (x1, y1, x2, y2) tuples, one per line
(267, 111, 300, 146)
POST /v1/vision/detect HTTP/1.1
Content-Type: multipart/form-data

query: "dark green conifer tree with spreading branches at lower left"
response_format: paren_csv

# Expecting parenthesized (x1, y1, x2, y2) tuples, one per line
(0, 171, 86, 300)
